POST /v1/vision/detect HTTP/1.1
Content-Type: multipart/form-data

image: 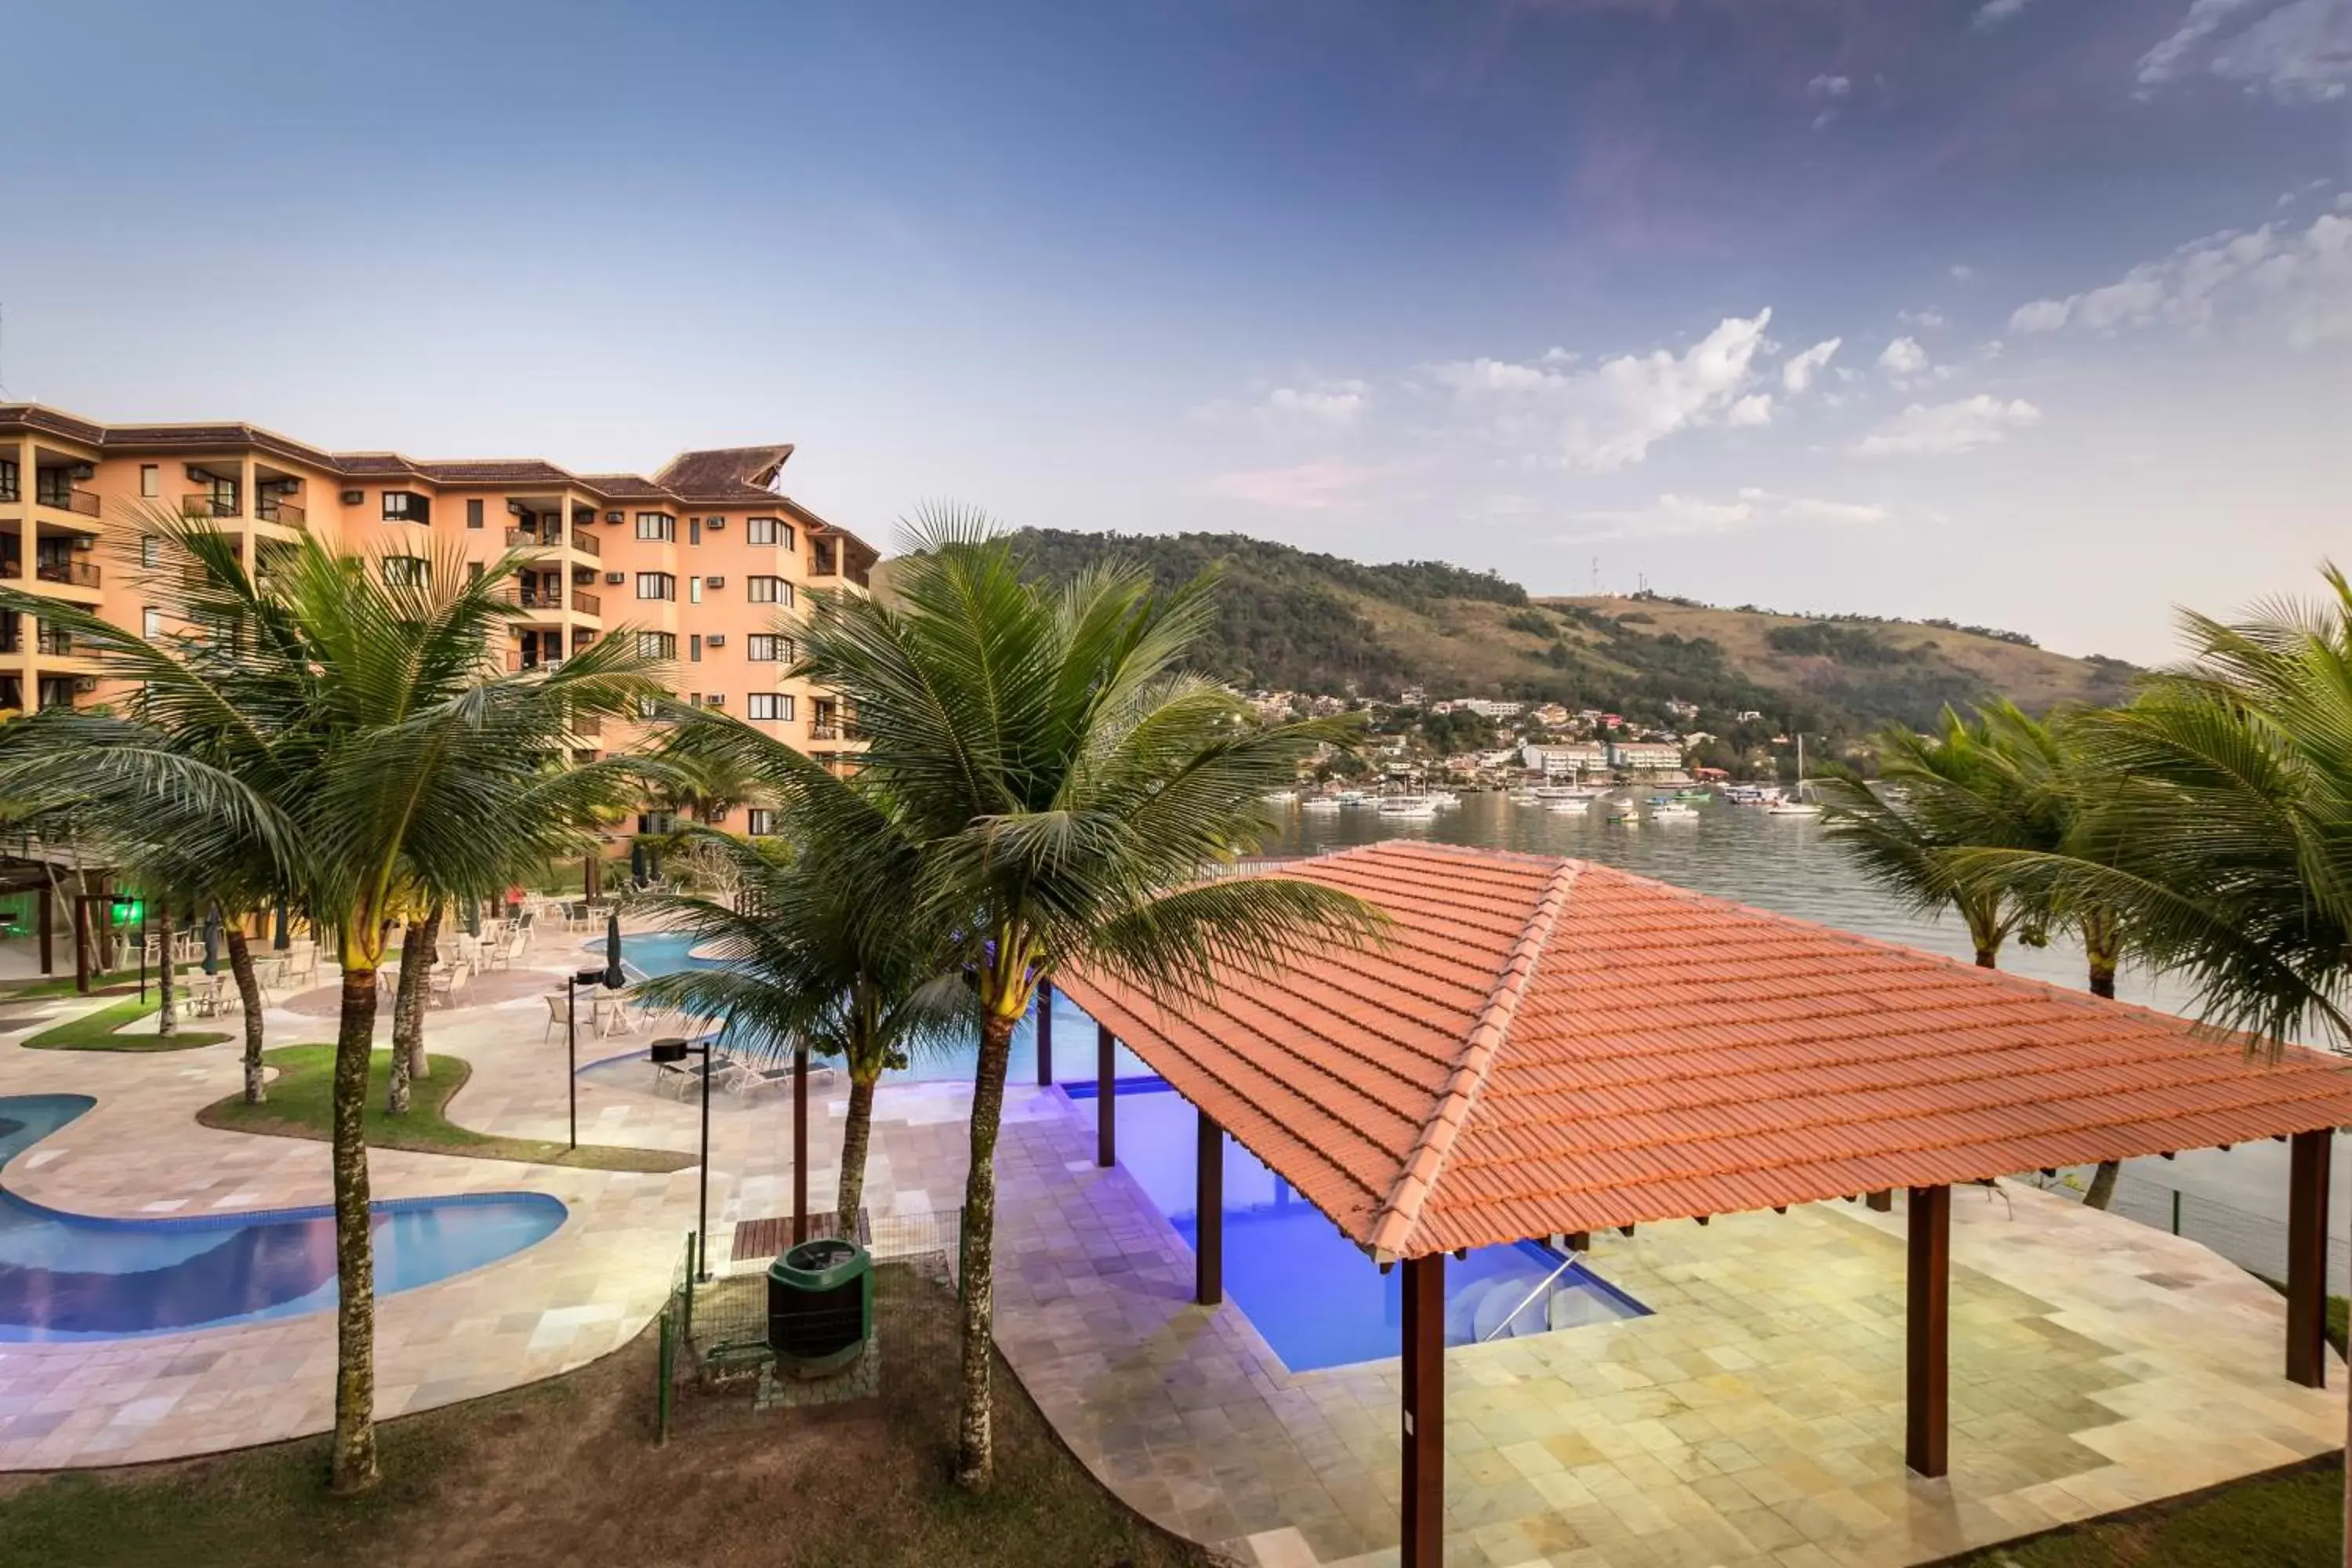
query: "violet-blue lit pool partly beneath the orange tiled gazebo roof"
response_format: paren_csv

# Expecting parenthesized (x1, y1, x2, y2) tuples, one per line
(1077, 1081, 1649, 1373)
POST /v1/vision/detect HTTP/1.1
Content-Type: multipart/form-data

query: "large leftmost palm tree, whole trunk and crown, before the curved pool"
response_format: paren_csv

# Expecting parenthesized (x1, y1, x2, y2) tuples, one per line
(0, 517, 656, 1490)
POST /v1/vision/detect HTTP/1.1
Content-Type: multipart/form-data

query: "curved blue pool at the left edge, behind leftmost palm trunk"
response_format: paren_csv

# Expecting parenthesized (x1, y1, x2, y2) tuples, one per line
(0, 1095, 564, 1342)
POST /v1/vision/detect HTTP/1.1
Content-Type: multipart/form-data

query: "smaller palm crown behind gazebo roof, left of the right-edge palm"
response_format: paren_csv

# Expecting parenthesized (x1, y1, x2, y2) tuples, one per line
(1816, 703, 2063, 968)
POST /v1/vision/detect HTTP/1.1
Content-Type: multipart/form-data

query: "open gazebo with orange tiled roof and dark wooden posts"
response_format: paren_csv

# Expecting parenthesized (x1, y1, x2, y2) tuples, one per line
(1040, 841, 2352, 1568)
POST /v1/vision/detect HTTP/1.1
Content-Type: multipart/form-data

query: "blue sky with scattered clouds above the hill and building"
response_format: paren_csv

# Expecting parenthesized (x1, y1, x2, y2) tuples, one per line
(0, 0, 2352, 663)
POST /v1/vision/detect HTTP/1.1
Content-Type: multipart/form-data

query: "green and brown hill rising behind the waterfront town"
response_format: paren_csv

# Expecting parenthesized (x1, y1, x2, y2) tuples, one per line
(946, 529, 2133, 731)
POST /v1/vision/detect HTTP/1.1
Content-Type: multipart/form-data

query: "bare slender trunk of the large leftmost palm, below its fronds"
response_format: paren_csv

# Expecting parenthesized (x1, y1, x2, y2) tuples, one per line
(329, 959, 376, 1493)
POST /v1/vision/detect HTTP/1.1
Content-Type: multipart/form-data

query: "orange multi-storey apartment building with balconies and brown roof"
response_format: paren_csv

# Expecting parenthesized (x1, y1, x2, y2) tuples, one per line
(0, 405, 877, 832)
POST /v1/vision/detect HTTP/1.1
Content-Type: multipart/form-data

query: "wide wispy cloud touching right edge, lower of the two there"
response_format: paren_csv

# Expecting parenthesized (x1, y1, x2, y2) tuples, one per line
(2009, 212, 2352, 348)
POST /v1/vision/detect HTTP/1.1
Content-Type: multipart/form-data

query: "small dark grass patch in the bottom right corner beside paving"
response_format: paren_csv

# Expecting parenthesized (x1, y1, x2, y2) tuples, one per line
(1955, 1457, 2345, 1568)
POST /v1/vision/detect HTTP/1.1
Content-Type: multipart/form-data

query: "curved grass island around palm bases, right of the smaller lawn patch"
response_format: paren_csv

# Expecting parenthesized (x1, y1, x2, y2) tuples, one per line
(195, 1046, 694, 1171)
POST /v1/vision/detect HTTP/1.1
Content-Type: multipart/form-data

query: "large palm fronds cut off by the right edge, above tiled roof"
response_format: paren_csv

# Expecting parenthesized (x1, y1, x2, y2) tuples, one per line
(1959, 564, 2352, 1566)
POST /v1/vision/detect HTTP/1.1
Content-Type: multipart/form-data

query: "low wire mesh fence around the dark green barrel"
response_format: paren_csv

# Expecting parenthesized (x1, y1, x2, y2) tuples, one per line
(654, 1208, 962, 1441)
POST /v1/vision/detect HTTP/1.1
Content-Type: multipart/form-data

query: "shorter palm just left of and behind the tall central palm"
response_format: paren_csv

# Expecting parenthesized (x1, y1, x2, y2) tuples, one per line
(642, 752, 976, 1236)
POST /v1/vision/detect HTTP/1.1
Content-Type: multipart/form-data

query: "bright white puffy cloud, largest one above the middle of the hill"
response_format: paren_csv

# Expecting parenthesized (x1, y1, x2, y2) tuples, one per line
(1430, 310, 1771, 473)
